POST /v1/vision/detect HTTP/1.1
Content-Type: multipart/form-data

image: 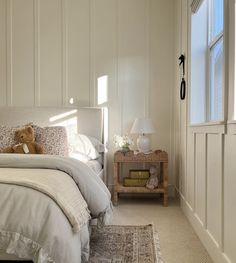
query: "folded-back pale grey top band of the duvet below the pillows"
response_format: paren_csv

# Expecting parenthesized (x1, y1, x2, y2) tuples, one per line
(0, 154, 112, 224)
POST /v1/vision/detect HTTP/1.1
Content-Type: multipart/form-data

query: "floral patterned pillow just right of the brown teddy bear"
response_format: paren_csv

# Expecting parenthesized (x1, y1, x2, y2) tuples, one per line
(33, 125, 69, 156)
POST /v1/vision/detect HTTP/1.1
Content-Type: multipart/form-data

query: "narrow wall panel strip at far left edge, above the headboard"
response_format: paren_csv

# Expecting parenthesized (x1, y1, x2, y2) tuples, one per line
(0, 0, 7, 106)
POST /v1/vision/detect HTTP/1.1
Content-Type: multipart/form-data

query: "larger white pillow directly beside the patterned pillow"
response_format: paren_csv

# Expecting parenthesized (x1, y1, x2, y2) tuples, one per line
(69, 134, 100, 160)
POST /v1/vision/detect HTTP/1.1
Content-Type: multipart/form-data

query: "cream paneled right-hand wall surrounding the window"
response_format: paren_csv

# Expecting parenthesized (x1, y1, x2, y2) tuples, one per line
(174, 0, 236, 263)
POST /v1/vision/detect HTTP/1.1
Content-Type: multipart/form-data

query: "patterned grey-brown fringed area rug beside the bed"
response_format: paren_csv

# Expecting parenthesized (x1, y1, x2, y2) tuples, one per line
(89, 225, 163, 263)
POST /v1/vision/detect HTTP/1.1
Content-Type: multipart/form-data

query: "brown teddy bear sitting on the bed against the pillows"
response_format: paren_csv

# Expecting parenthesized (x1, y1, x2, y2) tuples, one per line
(1, 126, 44, 154)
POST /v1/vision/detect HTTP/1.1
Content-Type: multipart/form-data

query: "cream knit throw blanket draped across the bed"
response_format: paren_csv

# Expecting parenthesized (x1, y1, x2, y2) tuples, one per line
(0, 168, 90, 233)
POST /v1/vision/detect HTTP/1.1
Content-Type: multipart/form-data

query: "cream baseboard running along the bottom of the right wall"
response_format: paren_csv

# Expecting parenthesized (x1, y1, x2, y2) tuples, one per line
(180, 195, 230, 263)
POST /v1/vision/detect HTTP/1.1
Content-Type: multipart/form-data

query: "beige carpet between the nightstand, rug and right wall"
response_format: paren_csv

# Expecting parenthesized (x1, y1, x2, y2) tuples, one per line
(113, 198, 212, 263)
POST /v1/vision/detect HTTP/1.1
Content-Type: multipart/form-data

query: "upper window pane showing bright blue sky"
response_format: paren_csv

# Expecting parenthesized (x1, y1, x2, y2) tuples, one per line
(211, 0, 224, 40)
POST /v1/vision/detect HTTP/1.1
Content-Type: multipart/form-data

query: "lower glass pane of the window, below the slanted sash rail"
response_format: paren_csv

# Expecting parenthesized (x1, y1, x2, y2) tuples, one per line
(209, 38, 223, 121)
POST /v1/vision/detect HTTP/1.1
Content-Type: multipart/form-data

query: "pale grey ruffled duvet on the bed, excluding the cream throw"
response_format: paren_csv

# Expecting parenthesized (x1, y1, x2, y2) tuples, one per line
(0, 154, 111, 263)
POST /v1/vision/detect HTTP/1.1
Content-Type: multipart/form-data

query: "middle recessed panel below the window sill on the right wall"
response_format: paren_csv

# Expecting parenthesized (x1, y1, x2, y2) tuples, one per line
(207, 134, 222, 248)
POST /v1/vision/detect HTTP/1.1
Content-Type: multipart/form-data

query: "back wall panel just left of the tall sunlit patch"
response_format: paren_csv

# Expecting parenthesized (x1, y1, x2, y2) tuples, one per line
(66, 0, 90, 106)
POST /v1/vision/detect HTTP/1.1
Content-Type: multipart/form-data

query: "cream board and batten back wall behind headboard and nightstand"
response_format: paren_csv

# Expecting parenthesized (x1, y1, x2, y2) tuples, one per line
(0, 0, 174, 193)
